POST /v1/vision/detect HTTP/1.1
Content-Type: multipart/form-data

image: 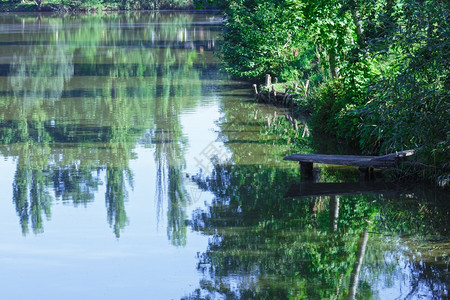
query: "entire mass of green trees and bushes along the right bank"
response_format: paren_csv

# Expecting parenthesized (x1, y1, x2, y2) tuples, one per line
(220, 0, 450, 185)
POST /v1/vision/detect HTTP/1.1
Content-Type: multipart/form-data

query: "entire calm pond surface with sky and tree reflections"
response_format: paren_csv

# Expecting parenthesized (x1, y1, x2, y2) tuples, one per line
(0, 12, 450, 299)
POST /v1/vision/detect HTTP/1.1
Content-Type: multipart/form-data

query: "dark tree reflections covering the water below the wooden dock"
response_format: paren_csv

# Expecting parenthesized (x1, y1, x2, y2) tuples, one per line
(185, 164, 450, 299)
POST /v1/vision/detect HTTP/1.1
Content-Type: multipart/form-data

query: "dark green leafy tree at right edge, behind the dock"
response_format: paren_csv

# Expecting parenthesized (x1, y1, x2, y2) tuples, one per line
(359, 1, 450, 178)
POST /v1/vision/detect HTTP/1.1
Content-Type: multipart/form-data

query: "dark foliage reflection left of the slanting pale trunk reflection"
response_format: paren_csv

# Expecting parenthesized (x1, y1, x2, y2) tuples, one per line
(188, 165, 372, 298)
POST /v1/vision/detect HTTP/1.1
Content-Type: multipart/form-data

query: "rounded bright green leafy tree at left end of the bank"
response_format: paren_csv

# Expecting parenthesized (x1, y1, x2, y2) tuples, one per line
(221, 0, 309, 79)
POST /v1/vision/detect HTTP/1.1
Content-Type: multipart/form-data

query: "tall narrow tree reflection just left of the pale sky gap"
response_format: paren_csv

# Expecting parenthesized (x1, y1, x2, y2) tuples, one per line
(153, 49, 201, 246)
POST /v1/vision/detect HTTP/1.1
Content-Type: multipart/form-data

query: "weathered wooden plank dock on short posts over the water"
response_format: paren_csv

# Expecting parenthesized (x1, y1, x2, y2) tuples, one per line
(283, 150, 414, 176)
